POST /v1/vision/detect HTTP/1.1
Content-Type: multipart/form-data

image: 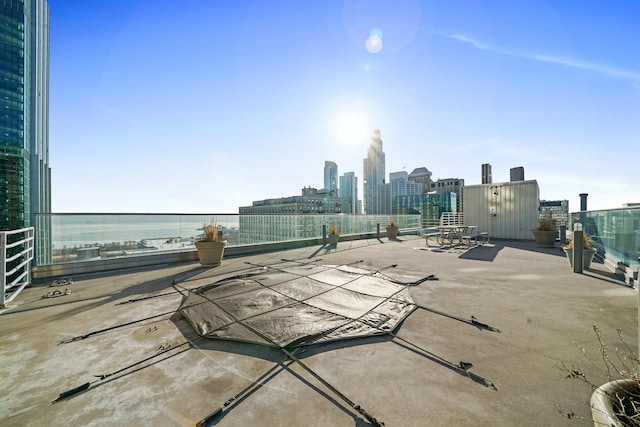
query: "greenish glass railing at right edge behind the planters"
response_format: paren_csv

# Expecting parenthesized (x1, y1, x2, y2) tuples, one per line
(569, 206, 640, 272)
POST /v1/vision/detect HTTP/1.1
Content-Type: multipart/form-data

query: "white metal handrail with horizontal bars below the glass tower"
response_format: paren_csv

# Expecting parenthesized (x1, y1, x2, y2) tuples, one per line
(0, 227, 35, 308)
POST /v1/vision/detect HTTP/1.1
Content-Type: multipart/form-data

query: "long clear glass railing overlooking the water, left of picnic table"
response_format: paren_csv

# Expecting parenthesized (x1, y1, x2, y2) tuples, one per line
(35, 214, 420, 266)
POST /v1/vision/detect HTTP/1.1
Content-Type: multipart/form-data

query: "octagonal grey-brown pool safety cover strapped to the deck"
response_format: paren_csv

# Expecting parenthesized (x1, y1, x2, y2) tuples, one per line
(179, 264, 416, 347)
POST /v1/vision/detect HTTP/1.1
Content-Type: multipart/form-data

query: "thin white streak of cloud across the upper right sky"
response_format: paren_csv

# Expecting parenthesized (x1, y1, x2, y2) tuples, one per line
(441, 33, 640, 83)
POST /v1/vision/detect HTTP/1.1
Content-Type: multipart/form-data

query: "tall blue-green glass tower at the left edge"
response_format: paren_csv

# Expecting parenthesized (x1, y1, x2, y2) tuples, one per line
(0, 0, 51, 234)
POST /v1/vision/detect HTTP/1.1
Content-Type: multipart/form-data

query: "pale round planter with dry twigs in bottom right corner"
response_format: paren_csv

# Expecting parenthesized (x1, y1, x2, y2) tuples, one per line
(591, 379, 640, 427)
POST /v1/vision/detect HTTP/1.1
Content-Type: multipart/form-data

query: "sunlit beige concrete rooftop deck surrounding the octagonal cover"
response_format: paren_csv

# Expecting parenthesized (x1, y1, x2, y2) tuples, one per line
(0, 236, 638, 427)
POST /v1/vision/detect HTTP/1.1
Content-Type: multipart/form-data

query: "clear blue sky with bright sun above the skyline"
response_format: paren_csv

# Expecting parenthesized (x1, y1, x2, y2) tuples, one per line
(49, 0, 640, 213)
